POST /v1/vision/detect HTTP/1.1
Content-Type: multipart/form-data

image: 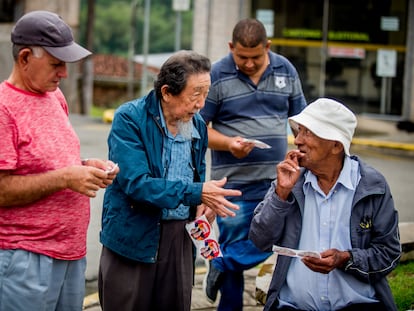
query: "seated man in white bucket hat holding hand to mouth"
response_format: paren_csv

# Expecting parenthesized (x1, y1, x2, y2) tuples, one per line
(249, 98, 401, 310)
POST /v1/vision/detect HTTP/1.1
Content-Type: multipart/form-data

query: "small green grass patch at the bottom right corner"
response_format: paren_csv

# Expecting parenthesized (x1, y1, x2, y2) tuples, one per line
(388, 261, 414, 311)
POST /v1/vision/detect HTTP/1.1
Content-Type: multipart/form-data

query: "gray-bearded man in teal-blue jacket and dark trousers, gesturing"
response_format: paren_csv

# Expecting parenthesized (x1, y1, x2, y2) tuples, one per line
(99, 51, 241, 311)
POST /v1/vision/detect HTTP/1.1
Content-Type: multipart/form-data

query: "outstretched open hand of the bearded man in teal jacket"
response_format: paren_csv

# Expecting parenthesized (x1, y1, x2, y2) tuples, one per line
(201, 178, 241, 217)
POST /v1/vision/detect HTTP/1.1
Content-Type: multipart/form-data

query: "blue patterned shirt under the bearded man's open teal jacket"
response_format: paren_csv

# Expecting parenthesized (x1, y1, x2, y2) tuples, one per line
(160, 108, 200, 220)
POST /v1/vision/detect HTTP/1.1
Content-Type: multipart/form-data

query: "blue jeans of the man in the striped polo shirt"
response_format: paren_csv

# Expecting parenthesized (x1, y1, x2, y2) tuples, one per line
(212, 200, 272, 311)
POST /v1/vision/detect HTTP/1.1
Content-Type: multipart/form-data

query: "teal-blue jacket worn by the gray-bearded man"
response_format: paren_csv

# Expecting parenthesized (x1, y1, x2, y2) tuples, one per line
(100, 91, 207, 263)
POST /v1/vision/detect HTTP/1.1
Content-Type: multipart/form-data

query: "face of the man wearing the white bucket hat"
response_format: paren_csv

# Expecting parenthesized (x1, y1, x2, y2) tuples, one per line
(294, 125, 335, 170)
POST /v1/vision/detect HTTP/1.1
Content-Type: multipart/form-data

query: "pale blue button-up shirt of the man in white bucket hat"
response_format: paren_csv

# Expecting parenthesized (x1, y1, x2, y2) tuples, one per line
(280, 156, 377, 310)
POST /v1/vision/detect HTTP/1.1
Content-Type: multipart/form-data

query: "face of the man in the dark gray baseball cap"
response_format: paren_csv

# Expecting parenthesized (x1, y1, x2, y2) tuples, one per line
(23, 49, 68, 93)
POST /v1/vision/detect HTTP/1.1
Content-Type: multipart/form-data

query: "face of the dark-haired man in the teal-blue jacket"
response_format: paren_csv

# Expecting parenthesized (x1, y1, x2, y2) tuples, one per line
(168, 72, 211, 122)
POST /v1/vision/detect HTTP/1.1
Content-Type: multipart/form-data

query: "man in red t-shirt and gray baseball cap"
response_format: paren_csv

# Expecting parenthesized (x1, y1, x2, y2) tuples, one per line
(0, 11, 119, 311)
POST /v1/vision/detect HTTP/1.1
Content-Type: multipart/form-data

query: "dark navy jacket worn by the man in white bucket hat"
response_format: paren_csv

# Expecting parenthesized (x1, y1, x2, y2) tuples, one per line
(249, 156, 401, 311)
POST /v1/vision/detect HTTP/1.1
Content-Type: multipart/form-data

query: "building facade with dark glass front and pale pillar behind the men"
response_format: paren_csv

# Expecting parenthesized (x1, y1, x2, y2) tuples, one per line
(193, 0, 414, 121)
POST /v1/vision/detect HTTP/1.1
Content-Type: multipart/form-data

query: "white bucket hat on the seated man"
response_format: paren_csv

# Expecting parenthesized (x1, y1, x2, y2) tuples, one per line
(289, 98, 357, 156)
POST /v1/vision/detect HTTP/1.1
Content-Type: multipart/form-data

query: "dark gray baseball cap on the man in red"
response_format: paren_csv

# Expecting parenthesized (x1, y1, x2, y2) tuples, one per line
(11, 11, 92, 63)
